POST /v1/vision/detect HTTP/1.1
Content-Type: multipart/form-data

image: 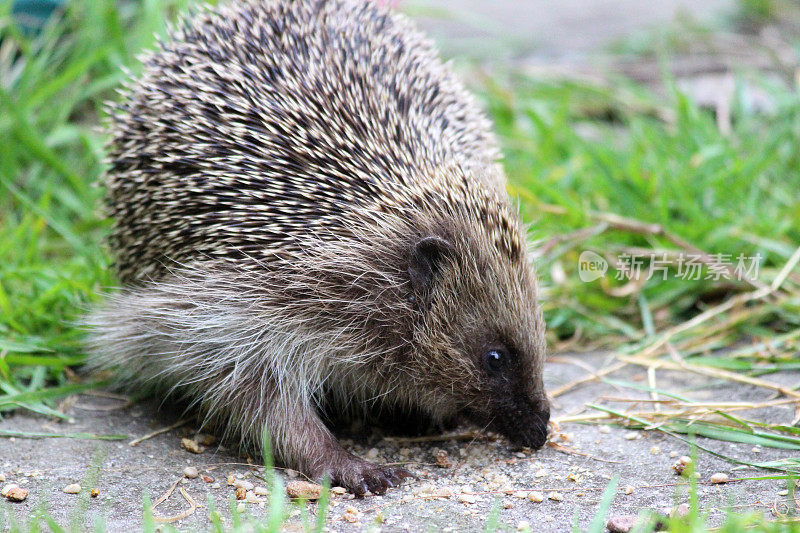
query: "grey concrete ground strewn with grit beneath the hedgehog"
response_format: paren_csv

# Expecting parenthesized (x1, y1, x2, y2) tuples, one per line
(0, 354, 800, 531)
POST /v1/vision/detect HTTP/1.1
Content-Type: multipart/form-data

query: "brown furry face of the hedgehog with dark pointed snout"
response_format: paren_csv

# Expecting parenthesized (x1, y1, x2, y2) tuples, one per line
(392, 183, 550, 448)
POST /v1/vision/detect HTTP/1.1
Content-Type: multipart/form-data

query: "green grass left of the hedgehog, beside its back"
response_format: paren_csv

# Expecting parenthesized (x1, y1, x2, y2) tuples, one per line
(0, 0, 194, 416)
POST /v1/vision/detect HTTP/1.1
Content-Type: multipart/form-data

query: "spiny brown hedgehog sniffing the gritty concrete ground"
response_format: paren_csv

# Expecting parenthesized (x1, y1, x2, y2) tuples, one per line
(88, 0, 550, 496)
